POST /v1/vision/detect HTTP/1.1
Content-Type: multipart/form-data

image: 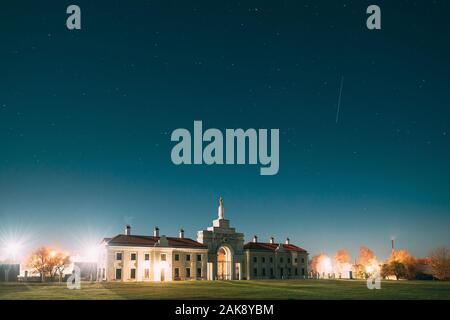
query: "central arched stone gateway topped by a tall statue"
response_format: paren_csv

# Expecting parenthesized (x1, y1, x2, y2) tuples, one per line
(197, 197, 244, 280)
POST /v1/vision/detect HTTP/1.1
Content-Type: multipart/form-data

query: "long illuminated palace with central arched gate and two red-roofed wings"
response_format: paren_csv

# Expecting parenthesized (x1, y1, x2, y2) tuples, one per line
(97, 198, 308, 281)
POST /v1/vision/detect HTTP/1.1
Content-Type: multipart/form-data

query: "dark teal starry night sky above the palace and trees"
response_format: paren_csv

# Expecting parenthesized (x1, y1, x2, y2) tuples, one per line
(0, 0, 450, 258)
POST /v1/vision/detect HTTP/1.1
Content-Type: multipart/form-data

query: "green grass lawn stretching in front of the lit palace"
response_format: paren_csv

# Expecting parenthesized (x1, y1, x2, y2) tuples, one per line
(0, 280, 450, 300)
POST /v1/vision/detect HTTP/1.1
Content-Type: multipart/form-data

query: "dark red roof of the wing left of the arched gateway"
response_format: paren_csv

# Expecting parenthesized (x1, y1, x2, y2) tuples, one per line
(104, 234, 207, 249)
